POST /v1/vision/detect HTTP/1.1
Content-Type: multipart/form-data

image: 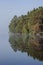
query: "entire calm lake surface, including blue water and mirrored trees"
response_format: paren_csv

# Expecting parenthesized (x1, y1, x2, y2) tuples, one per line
(0, 33, 43, 65)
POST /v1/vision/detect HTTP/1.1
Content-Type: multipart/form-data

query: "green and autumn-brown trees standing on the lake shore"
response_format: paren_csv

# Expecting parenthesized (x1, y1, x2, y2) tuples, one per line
(9, 7, 43, 34)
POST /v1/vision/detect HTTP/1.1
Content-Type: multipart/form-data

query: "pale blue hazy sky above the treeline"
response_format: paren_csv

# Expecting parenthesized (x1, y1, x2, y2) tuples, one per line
(0, 0, 43, 33)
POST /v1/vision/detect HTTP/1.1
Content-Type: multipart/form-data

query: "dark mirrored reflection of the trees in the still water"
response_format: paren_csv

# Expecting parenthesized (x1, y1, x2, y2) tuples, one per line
(9, 33, 43, 61)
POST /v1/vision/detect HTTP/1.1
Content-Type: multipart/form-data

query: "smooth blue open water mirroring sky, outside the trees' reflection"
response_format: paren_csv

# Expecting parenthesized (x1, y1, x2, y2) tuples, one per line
(0, 34, 43, 65)
